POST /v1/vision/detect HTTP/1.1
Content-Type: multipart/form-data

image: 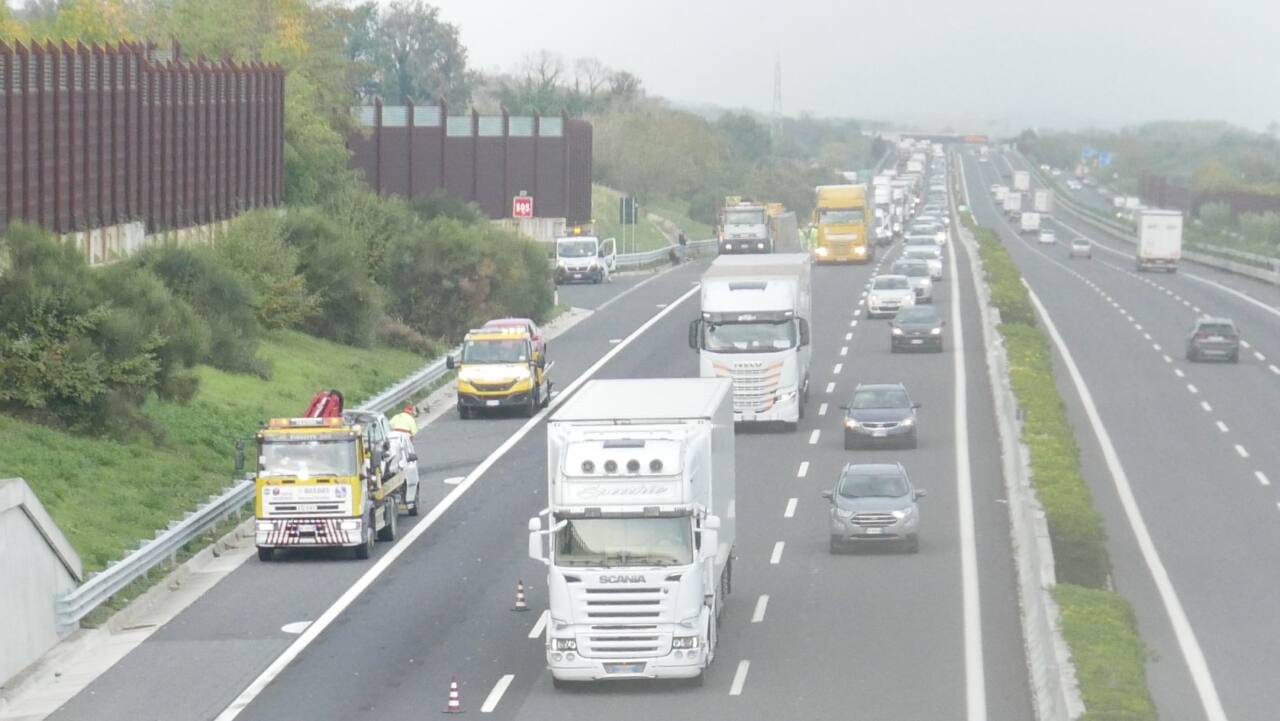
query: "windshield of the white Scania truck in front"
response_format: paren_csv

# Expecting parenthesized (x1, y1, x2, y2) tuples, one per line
(556, 516, 694, 567)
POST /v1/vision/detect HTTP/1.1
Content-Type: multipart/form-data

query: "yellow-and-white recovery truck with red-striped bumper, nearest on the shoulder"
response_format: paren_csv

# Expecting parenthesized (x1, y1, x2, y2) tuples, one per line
(253, 417, 407, 561)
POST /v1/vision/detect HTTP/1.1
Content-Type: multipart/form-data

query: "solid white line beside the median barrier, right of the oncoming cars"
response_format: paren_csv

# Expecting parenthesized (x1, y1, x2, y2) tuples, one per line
(947, 195, 987, 721)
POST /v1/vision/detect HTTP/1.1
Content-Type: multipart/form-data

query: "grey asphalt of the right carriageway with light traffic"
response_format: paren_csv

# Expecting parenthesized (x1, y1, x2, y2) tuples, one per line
(965, 151, 1280, 721)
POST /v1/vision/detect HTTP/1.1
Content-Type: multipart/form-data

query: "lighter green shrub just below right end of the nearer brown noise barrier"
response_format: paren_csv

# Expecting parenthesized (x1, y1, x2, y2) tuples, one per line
(214, 210, 319, 330)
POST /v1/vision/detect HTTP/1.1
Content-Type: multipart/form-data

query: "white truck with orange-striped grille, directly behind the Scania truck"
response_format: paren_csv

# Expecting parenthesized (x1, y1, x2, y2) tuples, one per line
(689, 254, 813, 430)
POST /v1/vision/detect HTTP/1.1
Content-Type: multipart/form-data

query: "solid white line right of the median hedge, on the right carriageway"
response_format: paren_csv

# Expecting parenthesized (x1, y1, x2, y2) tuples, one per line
(1027, 287, 1239, 721)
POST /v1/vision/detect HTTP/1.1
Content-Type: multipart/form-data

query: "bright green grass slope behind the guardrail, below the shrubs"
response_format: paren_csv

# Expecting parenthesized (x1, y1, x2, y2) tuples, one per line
(0, 332, 425, 571)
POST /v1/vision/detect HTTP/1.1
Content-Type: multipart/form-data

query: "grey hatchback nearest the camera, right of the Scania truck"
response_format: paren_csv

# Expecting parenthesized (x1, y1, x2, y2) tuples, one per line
(822, 464, 924, 553)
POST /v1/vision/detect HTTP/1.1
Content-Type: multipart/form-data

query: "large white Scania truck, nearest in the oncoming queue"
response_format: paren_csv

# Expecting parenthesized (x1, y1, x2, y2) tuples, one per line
(529, 378, 735, 688)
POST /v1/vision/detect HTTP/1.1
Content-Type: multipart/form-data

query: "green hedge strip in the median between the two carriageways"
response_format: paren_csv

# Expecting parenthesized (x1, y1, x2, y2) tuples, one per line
(961, 214, 1156, 721)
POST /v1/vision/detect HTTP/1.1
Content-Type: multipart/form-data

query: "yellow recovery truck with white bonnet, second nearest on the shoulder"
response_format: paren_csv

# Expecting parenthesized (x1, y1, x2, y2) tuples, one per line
(445, 328, 552, 419)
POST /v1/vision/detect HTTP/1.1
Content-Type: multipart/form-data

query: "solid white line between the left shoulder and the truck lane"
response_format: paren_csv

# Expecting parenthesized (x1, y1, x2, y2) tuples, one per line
(214, 285, 699, 721)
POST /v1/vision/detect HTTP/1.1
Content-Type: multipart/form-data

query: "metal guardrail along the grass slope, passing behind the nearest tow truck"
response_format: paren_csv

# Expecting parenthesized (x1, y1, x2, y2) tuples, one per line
(54, 348, 457, 630)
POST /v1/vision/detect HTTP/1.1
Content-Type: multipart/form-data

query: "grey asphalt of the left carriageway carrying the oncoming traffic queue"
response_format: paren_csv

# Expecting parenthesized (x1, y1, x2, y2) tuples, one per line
(45, 198, 1032, 721)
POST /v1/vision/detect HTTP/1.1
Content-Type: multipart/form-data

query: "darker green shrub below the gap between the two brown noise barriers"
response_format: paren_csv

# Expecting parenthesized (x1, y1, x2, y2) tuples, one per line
(284, 209, 383, 347)
